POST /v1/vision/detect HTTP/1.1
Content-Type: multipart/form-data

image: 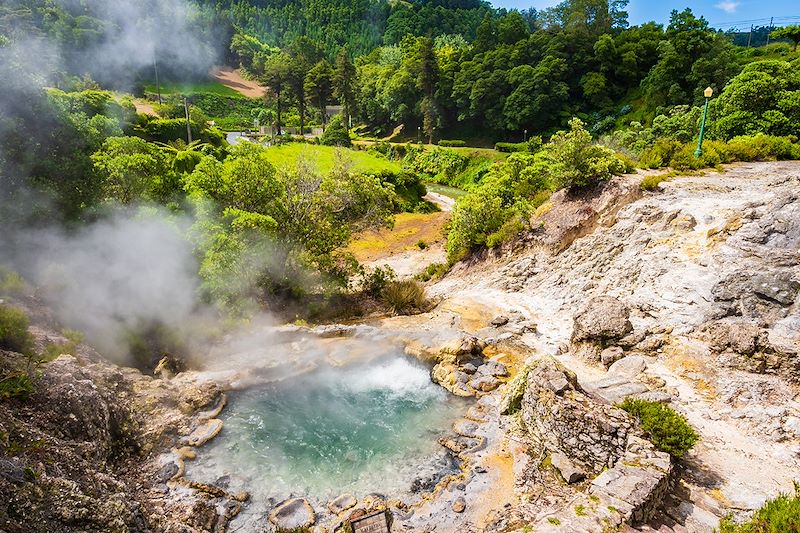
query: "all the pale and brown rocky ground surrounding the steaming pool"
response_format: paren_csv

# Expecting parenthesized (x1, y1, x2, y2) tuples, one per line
(0, 162, 800, 533)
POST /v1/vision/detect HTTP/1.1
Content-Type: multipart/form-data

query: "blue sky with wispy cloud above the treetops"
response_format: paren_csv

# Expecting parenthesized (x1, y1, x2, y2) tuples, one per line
(490, 0, 800, 29)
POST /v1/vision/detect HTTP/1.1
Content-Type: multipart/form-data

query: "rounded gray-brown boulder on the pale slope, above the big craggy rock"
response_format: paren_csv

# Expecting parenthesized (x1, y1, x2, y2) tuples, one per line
(572, 296, 633, 342)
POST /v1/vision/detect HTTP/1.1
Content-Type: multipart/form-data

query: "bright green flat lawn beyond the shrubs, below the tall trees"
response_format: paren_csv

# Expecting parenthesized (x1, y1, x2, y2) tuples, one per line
(267, 143, 402, 173)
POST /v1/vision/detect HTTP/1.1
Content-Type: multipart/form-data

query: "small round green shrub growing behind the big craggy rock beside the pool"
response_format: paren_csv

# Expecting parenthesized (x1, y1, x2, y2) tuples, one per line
(619, 398, 700, 459)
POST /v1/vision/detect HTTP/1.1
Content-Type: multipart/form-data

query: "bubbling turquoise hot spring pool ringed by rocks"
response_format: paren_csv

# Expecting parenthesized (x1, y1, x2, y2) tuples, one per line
(187, 353, 468, 505)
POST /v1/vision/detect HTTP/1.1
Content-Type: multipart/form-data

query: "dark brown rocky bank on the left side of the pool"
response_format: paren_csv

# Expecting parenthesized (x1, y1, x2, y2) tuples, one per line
(0, 290, 247, 533)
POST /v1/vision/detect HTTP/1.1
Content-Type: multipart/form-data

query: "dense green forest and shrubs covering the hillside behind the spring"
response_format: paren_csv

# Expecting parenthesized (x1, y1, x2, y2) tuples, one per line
(0, 0, 800, 312)
